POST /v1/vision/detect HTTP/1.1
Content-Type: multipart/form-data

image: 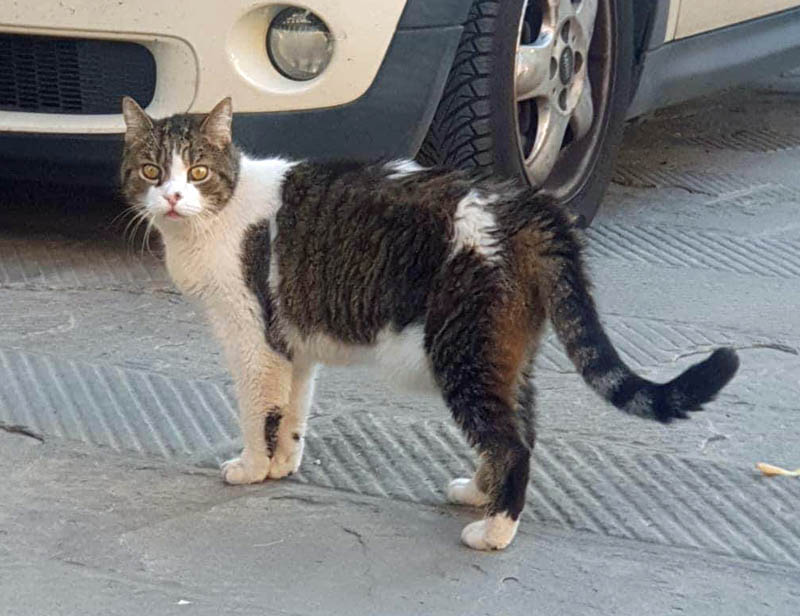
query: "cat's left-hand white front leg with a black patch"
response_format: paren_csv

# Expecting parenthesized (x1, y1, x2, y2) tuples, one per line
(222, 330, 292, 484)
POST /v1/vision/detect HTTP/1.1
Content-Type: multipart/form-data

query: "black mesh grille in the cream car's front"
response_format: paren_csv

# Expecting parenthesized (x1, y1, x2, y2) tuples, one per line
(0, 34, 156, 114)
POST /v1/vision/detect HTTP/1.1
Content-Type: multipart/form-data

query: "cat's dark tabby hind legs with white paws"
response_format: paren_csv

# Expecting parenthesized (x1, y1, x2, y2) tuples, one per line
(426, 270, 535, 550)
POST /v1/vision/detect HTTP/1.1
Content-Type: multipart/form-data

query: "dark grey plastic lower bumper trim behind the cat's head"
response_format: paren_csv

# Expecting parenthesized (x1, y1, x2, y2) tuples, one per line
(0, 26, 462, 185)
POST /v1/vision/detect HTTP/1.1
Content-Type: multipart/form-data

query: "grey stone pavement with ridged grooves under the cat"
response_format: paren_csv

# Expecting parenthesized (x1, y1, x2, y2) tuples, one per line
(0, 74, 800, 616)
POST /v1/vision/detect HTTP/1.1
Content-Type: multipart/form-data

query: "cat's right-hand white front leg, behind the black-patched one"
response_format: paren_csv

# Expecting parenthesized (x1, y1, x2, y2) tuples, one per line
(269, 359, 316, 479)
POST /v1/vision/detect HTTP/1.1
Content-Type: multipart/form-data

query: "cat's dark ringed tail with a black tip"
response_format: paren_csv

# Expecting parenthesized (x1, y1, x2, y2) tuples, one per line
(540, 214, 739, 423)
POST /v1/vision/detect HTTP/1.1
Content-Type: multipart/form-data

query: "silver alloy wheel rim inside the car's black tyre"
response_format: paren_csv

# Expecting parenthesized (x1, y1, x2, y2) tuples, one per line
(514, 0, 611, 193)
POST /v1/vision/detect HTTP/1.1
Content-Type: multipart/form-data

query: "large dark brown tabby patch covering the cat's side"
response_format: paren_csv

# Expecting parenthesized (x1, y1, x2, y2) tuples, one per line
(272, 162, 458, 344)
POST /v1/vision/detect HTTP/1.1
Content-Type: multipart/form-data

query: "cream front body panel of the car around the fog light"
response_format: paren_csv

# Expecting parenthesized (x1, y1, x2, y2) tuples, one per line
(0, 0, 406, 134)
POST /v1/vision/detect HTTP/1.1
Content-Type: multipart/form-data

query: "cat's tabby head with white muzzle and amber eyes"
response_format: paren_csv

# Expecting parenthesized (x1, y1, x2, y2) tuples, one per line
(120, 97, 240, 227)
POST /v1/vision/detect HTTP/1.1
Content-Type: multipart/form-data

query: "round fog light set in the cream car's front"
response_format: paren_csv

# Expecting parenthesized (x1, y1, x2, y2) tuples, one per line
(267, 7, 333, 81)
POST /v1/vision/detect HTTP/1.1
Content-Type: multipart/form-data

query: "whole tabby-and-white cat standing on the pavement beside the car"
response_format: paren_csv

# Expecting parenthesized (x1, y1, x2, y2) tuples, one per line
(120, 98, 738, 550)
